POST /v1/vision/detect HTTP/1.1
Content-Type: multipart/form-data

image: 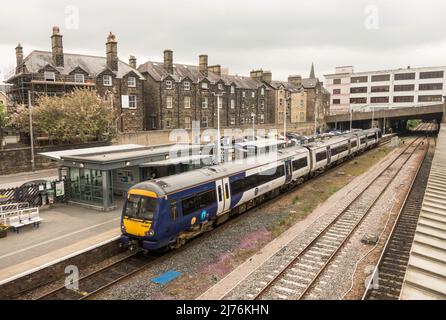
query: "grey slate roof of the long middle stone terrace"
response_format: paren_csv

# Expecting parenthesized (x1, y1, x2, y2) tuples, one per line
(138, 61, 264, 89)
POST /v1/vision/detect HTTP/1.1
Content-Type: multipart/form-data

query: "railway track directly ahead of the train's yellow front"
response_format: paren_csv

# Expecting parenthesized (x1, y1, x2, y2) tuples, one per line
(37, 251, 158, 300)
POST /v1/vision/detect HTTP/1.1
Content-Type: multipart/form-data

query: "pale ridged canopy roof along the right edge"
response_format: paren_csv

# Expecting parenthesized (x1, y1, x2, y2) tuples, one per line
(400, 124, 446, 300)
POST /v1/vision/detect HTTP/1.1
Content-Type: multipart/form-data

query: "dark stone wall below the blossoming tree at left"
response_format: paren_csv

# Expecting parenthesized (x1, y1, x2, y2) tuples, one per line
(0, 142, 111, 175)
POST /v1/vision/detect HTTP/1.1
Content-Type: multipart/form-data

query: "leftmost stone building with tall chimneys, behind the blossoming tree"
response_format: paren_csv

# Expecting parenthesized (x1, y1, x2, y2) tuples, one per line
(7, 27, 145, 131)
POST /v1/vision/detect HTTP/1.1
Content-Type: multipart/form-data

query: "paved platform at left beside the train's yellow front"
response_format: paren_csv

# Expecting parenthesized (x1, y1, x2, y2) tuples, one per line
(0, 203, 122, 284)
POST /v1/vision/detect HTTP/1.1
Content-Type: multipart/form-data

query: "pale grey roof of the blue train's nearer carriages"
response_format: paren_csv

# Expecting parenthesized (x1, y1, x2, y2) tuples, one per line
(132, 146, 309, 196)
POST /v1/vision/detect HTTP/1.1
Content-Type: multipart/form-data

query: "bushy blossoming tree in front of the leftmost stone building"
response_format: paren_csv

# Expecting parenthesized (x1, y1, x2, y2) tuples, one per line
(10, 89, 115, 142)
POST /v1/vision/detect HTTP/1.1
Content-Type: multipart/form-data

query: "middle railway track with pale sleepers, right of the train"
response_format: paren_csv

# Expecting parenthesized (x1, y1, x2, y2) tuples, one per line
(253, 138, 424, 300)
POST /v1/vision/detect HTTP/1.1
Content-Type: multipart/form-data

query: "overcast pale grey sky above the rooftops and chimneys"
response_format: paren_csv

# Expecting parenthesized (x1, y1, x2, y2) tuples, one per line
(0, 0, 446, 80)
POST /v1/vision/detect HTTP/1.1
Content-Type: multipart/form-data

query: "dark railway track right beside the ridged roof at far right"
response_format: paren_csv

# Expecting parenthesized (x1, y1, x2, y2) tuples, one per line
(363, 138, 433, 300)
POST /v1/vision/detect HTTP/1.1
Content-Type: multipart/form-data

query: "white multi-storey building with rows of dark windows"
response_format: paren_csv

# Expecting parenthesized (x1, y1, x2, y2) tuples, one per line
(325, 66, 446, 113)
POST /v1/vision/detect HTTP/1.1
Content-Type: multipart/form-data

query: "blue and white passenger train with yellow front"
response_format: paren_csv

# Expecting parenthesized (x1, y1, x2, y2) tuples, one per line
(120, 128, 382, 251)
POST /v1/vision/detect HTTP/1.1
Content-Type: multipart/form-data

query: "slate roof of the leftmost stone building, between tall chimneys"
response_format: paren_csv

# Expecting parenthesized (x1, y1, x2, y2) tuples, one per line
(9, 50, 144, 79)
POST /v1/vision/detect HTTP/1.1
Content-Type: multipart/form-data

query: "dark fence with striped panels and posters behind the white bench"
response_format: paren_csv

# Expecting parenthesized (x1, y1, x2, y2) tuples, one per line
(0, 180, 70, 207)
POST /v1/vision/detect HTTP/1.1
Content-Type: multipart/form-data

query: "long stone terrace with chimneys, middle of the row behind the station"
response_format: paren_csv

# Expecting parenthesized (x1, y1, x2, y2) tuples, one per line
(138, 50, 271, 130)
